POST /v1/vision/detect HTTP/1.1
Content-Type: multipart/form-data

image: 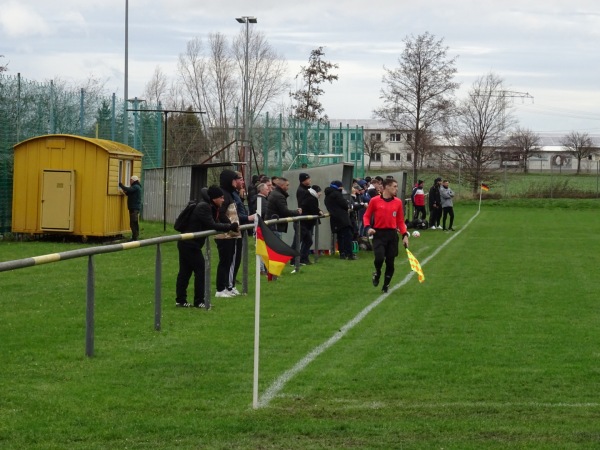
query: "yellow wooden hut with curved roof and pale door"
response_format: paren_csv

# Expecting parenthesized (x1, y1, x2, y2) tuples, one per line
(12, 134, 142, 237)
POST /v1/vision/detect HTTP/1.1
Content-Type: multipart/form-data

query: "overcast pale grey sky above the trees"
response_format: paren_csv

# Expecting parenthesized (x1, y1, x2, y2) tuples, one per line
(0, 0, 600, 134)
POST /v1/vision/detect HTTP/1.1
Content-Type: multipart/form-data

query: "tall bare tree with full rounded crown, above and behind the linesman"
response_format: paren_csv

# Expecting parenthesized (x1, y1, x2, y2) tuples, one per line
(374, 32, 459, 183)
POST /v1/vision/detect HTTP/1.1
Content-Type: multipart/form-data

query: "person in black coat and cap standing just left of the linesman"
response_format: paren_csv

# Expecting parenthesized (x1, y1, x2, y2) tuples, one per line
(325, 180, 357, 260)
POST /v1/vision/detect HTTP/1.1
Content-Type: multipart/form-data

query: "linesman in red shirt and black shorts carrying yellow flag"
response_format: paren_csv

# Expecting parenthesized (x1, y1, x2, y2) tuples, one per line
(363, 178, 408, 292)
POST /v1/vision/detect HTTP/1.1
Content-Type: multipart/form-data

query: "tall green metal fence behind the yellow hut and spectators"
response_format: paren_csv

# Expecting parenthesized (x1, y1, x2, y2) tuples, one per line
(0, 74, 364, 233)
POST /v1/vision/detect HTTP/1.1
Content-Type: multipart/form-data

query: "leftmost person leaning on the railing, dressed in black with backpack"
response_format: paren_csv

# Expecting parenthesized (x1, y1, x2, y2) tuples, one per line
(175, 185, 239, 308)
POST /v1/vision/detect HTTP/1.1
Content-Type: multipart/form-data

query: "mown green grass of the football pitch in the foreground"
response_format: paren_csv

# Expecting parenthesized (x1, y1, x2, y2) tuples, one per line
(0, 199, 600, 449)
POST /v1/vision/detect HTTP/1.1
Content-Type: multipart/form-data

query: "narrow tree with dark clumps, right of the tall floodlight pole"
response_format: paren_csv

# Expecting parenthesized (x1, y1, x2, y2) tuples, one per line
(290, 47, 339, 122)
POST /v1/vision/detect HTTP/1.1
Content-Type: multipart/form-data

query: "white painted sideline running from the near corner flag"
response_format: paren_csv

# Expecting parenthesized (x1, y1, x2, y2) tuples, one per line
(257, 211, 479, 408)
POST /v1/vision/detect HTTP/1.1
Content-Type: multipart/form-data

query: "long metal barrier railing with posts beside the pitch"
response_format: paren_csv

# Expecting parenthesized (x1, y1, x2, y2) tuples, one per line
(0, 214, 329, 357)
